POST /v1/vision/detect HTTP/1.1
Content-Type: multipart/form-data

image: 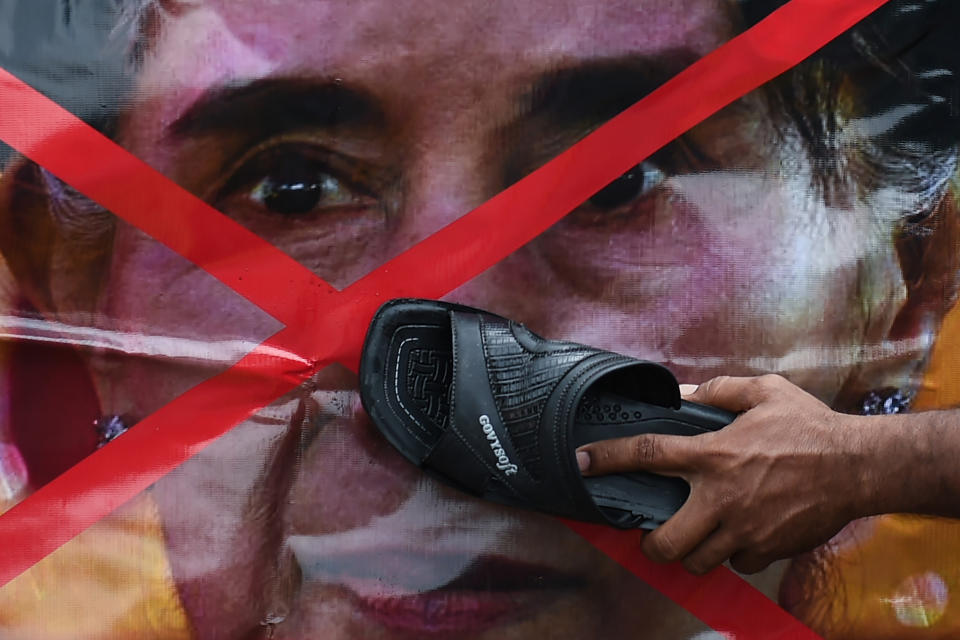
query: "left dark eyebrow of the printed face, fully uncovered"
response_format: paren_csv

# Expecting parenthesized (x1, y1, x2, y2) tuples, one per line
(168, 78, 386, 137)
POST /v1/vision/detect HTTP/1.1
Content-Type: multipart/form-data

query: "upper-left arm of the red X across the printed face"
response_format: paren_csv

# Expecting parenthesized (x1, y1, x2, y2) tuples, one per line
(0, 69, 335, 325)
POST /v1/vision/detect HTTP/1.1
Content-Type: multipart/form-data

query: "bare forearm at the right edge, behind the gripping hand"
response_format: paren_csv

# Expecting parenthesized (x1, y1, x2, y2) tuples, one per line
(854, 410, 960, 518)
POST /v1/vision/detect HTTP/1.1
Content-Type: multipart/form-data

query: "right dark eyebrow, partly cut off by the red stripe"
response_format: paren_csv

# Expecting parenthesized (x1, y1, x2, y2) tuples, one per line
(526, 48, 701, 127)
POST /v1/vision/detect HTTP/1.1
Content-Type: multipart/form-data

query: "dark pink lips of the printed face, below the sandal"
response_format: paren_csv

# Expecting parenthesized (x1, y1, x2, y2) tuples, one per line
(348, 556, 584, 637)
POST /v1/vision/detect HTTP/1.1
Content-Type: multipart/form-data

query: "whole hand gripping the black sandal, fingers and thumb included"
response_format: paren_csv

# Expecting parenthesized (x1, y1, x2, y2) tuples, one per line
(578, 375, 876, 574)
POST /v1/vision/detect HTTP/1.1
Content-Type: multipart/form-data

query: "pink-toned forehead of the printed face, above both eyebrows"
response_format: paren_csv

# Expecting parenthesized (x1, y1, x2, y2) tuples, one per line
(141, 0, 731, 100)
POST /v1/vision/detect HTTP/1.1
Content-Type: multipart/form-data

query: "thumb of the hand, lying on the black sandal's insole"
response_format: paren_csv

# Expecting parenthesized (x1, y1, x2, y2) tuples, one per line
(577, 433, 700, 476)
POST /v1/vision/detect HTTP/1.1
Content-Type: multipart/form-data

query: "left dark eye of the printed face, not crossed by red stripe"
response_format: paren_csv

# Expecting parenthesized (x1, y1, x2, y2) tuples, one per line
(249, 156, 369, 216)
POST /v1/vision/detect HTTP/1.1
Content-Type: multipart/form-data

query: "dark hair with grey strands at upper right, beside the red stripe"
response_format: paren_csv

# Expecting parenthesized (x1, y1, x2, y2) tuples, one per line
(740, 0, 960, 219)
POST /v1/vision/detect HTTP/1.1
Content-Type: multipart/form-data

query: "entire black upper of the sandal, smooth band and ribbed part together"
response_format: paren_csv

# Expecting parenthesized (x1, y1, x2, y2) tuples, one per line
(423, 310, 680, 526)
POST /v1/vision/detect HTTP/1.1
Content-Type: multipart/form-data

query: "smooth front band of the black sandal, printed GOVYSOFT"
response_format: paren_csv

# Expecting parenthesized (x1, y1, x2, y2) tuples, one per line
(424, 311, 531, 498)
